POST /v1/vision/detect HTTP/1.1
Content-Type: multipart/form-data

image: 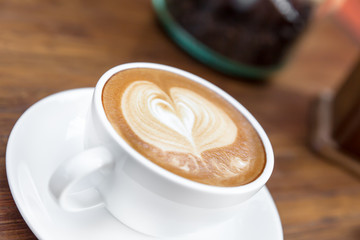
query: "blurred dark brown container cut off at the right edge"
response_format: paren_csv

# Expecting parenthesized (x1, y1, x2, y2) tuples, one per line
(311, 59, 360, 176)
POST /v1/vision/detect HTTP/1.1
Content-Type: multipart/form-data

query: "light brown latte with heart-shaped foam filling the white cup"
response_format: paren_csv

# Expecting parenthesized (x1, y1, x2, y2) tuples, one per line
(102, 68, 266, 187)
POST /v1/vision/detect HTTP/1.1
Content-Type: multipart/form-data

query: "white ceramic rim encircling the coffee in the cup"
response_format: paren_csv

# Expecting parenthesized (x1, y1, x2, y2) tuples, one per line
(93, 62, 274, 195)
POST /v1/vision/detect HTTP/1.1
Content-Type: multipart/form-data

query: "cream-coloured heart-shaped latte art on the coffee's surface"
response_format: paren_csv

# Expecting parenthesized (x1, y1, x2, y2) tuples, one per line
(121, 81, 237, 158)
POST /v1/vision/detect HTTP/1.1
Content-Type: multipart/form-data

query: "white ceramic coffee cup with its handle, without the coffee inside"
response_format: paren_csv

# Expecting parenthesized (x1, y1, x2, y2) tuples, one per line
(49, 63, 274, 237)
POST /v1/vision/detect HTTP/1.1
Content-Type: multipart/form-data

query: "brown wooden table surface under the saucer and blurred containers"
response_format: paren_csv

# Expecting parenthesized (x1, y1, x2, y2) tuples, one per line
(0, 0, 360, 240)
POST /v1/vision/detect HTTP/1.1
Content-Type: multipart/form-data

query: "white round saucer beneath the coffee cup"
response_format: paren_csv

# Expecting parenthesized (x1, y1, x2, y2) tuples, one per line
(6, 88, 283, 240)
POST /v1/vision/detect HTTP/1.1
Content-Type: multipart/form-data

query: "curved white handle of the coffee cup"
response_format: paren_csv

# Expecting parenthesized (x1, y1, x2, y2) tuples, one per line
(49, 146, 115, 212)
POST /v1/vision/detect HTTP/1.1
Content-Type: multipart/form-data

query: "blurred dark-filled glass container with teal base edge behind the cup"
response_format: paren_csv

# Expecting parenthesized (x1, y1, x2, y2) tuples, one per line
(153, 0, 313, 78)
